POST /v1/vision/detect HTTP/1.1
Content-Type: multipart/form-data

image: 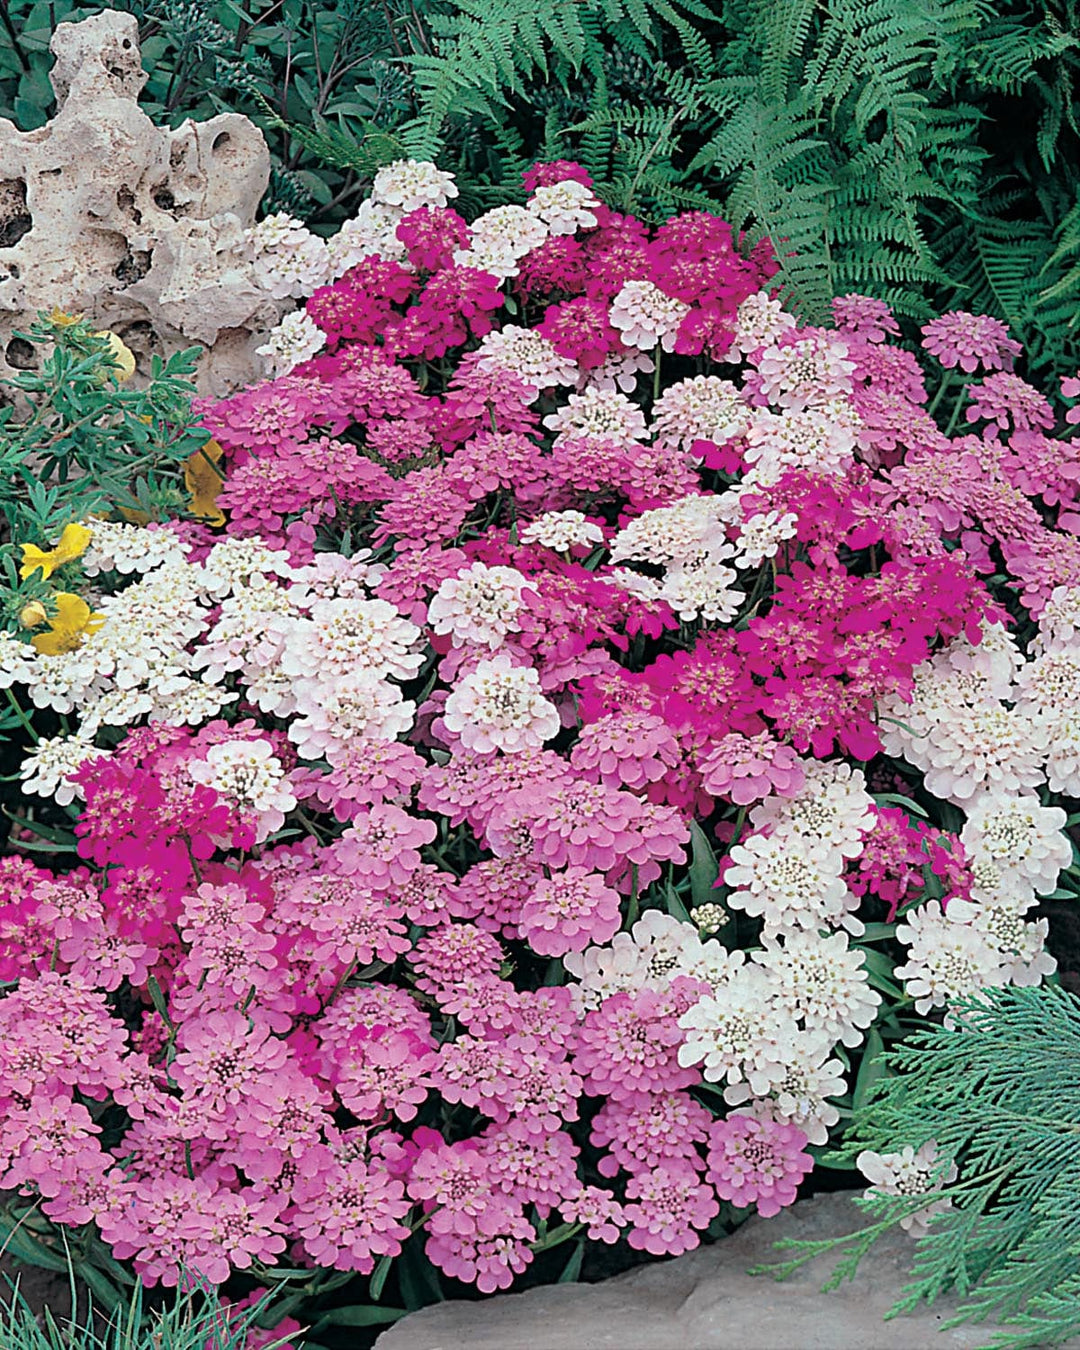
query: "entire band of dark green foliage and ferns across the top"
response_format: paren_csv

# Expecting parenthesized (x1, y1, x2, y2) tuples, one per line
(0, 0, 1080, 369)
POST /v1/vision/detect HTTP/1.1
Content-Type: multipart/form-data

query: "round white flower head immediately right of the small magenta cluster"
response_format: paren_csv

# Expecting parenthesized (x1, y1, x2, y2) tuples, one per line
(960, 792, 1072, 895)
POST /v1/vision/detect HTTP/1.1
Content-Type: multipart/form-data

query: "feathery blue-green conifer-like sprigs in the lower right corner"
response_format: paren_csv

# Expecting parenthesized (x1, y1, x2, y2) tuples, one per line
(761, 987, 1080, 1350)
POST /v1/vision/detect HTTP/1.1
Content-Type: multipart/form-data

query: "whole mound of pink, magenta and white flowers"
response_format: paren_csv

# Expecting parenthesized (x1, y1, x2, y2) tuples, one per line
(0, 162, 1080, 1335)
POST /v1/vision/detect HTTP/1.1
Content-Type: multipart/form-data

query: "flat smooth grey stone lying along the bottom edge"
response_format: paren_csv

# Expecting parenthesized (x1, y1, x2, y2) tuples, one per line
(375, 1195, 1080, 1350)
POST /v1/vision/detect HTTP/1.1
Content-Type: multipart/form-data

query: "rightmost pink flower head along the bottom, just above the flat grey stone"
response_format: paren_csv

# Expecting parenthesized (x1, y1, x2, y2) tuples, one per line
(707, 1115, 814, 1219)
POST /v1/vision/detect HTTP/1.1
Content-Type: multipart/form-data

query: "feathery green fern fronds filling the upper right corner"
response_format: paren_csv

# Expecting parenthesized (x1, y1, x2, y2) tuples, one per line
(396, 0, 1080, 371)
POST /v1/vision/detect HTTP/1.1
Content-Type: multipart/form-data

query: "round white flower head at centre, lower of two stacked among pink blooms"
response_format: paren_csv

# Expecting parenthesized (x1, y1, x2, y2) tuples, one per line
(443, 652, 562, 755)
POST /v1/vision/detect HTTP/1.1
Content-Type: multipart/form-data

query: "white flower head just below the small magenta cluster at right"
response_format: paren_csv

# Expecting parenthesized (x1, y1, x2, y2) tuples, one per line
(895, 900, 1006, 1026)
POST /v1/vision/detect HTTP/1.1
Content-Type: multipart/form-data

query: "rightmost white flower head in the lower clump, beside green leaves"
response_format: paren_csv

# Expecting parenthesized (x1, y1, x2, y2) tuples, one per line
(753, 934, 880, 1046)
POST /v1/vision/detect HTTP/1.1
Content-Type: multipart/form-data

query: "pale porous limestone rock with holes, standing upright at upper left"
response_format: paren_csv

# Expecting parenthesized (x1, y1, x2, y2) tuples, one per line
(0, 11, 286, 396)
